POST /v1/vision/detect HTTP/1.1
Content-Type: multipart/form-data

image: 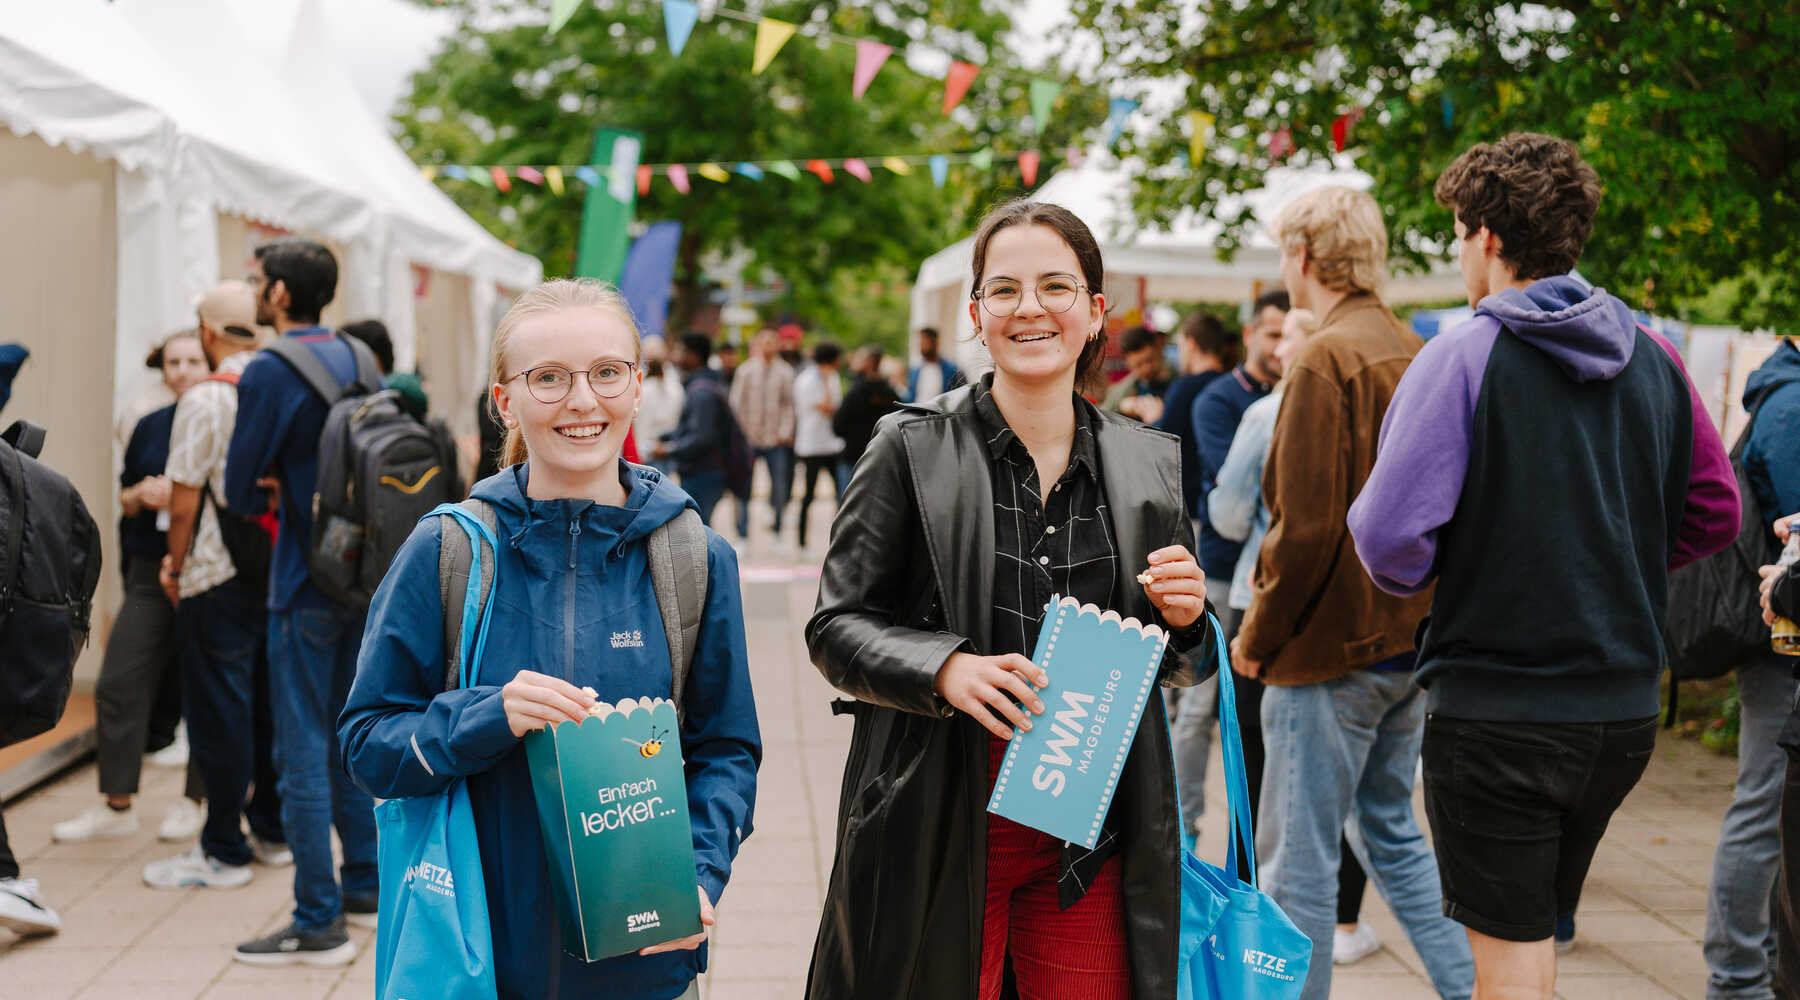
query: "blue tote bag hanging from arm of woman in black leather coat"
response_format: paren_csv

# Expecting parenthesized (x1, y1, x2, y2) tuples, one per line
(1175, 615, 1312, 1000)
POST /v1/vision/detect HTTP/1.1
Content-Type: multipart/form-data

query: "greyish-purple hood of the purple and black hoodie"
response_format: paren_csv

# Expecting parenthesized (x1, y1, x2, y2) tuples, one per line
(1476, 275, 1638, 381)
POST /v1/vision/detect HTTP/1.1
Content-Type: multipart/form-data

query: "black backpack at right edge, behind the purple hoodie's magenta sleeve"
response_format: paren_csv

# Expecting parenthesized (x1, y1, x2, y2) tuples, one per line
(1663, 405, 1775, 727)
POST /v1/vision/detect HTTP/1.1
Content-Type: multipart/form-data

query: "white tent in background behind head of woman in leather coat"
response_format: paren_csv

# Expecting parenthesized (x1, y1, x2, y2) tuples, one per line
(911, 156, 1463, 365)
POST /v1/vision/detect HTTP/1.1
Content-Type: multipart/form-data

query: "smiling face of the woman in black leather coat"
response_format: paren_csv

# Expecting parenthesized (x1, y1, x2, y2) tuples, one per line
(968, 225, 1105, 387)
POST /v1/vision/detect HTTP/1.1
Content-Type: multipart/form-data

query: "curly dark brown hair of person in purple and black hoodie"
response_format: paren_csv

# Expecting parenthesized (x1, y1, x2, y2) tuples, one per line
(1433, 131, 1600, 279)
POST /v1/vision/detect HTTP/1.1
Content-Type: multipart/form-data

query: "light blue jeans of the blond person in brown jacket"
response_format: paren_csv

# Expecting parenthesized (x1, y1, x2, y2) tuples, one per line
(1256, 671, 1474, 1000)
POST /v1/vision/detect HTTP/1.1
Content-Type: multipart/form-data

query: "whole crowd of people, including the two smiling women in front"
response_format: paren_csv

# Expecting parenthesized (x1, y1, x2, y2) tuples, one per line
(0, 126, 1800, 1000)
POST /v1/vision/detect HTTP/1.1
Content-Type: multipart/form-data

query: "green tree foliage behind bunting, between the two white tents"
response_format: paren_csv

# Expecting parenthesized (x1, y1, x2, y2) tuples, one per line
(398, 0, 1105, 338)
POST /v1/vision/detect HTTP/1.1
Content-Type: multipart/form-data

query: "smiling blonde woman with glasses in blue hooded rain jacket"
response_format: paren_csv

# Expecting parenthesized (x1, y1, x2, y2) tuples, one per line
(338, 281, 761, 1000)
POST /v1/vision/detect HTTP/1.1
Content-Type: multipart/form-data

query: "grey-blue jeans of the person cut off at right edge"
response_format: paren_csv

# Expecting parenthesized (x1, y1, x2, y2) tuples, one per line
(1705, 655, 1795, 1000)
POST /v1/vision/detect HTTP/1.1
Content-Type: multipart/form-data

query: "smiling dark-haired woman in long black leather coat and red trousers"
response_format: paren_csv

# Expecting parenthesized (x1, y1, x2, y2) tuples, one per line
(806, 201, 1217, 1000)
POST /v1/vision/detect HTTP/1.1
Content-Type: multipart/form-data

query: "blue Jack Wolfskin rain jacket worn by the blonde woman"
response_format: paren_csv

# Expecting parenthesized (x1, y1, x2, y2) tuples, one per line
(338, 464, 761, 1000)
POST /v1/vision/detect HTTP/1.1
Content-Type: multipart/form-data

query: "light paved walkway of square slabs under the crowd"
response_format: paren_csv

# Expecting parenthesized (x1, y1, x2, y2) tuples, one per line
(0, 528, 1735, 1000)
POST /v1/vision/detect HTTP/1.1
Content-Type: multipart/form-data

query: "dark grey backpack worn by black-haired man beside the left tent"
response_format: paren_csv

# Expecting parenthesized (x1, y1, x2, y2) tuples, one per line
(275, 335, 464, 608)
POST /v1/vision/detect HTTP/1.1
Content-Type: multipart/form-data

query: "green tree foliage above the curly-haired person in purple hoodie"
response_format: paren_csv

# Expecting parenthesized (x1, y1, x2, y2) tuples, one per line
(1075, 0, 1800, 331)
